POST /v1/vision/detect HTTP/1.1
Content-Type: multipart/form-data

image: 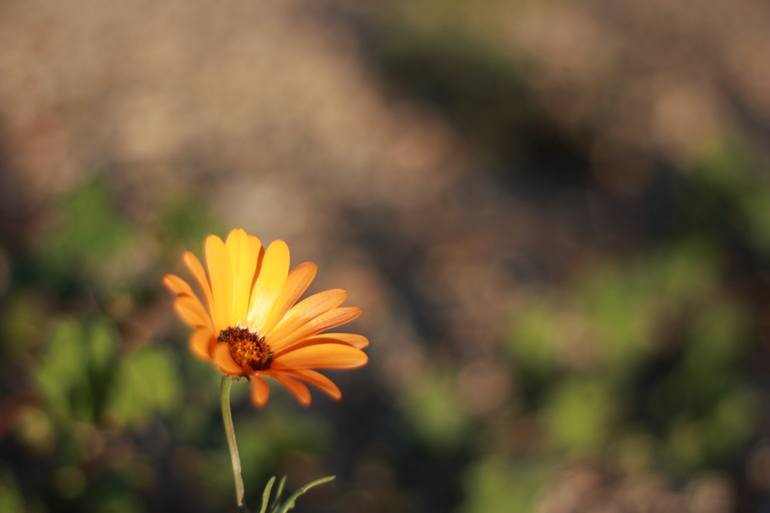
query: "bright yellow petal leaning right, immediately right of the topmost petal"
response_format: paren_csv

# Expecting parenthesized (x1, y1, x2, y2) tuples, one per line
(248, 240, 289, 333)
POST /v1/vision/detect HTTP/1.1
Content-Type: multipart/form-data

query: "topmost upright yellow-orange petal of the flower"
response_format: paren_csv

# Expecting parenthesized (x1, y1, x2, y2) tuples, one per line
(225, 228, 262, 326)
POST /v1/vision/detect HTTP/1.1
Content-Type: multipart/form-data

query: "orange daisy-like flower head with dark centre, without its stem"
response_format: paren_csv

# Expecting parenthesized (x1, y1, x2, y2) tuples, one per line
(163, 229, 369, 406)
